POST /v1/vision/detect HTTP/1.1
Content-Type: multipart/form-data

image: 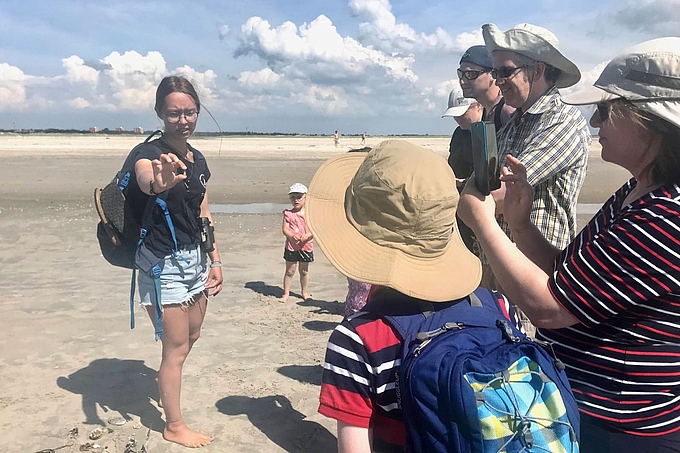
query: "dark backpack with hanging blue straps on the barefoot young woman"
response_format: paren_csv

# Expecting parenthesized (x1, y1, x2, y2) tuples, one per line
(94, 131, 177, 340)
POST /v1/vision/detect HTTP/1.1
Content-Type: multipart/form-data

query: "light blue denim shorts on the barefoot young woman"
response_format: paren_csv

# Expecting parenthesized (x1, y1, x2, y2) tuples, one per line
(138, 246, 208, 305)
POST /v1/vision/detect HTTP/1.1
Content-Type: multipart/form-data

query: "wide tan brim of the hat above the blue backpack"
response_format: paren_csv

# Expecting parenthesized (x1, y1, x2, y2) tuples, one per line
(306, 153, 482, 302)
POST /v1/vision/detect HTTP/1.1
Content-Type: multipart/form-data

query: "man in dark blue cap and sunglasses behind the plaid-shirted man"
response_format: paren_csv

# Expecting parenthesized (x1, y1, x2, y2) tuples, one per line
(457, 46, 515, 131)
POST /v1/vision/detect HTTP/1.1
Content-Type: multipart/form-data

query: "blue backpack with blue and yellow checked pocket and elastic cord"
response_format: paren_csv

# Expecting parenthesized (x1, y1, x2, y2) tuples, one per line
(372, 288, 580, 453)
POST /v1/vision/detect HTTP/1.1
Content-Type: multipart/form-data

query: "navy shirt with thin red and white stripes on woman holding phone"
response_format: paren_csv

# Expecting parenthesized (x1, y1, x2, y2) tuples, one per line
(540, 180, 680, 436)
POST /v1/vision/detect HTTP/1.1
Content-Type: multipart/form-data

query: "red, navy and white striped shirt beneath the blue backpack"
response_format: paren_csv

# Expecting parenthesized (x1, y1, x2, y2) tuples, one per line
(319, 293, 521, 453)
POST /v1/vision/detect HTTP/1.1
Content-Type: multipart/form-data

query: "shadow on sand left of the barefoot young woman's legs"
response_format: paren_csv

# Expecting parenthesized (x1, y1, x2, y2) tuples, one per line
(57, 359, 165, 432)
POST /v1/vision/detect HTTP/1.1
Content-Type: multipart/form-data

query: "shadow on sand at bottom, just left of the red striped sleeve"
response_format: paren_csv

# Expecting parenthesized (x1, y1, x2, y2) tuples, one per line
(215, 395, 338, 452)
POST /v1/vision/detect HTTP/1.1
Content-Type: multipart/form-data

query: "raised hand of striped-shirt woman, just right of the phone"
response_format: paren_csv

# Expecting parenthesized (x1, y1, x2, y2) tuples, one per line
(501, 155, 534, 229)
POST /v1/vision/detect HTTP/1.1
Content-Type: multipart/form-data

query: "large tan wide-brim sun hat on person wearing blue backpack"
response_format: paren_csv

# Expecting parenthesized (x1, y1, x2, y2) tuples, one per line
(306, 140, 482, 302)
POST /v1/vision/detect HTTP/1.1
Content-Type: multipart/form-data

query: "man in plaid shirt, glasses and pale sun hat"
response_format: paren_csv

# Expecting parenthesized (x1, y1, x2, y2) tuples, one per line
(482, 24, 591, 333)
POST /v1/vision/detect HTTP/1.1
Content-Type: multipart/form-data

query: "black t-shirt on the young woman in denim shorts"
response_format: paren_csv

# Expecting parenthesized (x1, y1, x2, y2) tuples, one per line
(127, 140, 210, 258)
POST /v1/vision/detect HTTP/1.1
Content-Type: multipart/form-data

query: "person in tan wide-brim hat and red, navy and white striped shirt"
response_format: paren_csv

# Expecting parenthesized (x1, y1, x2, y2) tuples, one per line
(307, 140, 521, 453)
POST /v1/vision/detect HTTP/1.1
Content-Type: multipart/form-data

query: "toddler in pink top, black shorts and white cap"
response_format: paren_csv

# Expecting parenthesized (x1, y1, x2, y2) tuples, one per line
(279, 182, 314, 302)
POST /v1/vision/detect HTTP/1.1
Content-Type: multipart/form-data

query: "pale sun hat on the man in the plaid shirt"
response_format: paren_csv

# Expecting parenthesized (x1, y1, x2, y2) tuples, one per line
(482, 24, 581, 88)
